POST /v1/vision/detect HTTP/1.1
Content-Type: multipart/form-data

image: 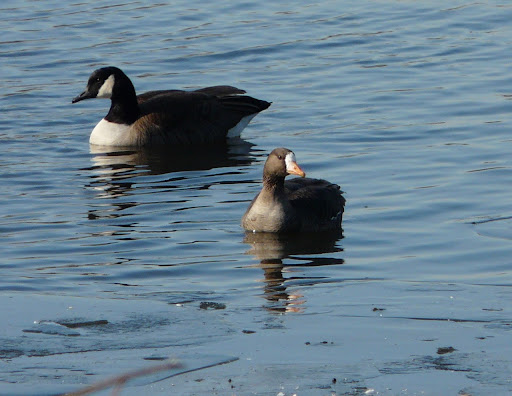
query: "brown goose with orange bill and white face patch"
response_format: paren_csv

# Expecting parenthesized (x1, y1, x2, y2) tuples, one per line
(242, 148, 345, 232)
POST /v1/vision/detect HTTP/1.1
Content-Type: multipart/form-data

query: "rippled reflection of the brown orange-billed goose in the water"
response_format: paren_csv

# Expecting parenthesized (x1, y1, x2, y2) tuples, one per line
(244, 230, 344, 313)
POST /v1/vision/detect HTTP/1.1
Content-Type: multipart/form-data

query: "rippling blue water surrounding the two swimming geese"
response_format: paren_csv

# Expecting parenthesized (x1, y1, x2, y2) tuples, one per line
(0, 0, 512, 395)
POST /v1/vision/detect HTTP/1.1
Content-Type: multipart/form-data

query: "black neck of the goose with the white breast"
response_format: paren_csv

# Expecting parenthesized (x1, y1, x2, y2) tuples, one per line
(105, 76, 140, 125)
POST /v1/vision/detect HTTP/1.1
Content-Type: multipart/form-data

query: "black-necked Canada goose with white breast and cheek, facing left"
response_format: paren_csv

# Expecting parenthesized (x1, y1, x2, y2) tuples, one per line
(72, 66, 270, 146)
